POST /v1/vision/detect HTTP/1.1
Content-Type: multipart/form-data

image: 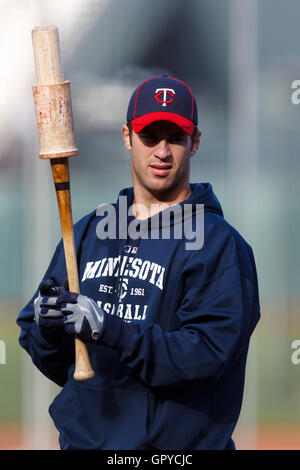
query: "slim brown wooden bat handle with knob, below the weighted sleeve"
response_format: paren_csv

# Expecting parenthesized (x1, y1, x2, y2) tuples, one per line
(50, 157, 95, 380)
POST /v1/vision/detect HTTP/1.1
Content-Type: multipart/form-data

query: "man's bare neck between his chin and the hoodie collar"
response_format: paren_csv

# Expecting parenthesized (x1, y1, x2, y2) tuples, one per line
(132, 184, 192, 219)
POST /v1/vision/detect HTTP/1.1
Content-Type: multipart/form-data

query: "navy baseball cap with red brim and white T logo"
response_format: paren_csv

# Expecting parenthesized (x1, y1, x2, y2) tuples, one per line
(127, 75, 198, 135)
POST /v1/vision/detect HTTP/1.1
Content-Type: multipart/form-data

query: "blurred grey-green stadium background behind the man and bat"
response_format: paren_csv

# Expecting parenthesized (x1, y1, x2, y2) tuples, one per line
(0, 0, 300, 449)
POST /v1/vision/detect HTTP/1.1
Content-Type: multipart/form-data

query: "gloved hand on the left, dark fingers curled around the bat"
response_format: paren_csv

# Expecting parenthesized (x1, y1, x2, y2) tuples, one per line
(34, 279, 66, 339)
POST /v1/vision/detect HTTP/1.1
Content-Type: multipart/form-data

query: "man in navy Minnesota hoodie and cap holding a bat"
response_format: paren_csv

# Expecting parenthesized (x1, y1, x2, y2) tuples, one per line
(17, 76, 260, 450)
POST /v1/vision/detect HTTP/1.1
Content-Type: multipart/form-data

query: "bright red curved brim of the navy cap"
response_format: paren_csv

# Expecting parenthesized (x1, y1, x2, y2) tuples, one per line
(132, 112, 195, 135)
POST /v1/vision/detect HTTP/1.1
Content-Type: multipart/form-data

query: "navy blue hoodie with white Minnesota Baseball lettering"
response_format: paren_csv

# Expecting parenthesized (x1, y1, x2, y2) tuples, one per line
(17, 183, 260, 450)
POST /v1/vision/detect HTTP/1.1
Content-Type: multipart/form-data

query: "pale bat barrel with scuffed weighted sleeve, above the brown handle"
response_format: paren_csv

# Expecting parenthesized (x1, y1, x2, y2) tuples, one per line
(32, 25, 79, 159)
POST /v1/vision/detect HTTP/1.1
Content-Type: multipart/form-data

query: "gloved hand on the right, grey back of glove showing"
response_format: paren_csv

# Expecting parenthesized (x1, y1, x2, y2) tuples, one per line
(57, 291, 104, 343)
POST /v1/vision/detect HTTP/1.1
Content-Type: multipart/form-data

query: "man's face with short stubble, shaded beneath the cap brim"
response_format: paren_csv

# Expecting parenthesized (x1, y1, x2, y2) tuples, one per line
(123, 121, 199, 198)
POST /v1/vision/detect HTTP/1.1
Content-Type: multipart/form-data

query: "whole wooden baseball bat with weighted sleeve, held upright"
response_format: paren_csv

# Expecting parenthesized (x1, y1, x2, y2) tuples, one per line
(32, 25, 95, 380)
